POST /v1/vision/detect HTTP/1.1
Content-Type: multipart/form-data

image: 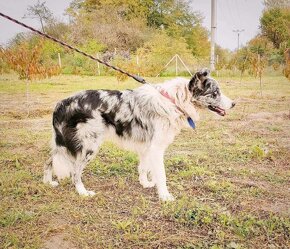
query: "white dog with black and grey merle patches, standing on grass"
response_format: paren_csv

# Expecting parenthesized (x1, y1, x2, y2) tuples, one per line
(43, 69, 235, 201)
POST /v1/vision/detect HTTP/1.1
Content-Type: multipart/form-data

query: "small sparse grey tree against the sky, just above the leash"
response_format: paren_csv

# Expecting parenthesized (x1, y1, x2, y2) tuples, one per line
(24, 0, 53, 32)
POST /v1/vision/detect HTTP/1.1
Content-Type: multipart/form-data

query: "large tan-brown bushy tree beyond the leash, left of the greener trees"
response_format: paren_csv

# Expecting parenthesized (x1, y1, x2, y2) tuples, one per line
(68, 6, 150, 51)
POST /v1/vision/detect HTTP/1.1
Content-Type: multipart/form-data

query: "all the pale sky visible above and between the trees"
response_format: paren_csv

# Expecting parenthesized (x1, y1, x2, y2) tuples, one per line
(0, 0, 263, 50)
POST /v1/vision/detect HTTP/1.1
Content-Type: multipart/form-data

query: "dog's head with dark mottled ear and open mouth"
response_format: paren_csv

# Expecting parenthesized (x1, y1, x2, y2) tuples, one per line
(188, 68, 235, 116)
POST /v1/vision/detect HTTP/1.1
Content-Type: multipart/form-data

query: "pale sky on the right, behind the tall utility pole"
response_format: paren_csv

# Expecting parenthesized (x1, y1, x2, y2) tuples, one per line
(192, 0, 264, 50)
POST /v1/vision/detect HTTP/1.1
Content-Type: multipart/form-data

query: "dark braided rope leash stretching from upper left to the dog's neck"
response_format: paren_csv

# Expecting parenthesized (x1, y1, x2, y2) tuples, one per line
(0, 12, 147, 84)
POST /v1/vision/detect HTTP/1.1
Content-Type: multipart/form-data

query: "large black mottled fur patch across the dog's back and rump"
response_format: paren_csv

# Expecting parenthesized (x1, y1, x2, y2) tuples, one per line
(53, 90, 148, 156)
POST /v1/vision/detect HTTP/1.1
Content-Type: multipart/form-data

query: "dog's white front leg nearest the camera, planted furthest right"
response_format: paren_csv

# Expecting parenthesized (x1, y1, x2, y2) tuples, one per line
(147, 146, 174, 201)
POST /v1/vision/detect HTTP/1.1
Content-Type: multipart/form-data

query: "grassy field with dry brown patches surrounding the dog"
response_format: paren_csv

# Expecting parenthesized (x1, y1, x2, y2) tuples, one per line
(0, 75, 290, 249)
